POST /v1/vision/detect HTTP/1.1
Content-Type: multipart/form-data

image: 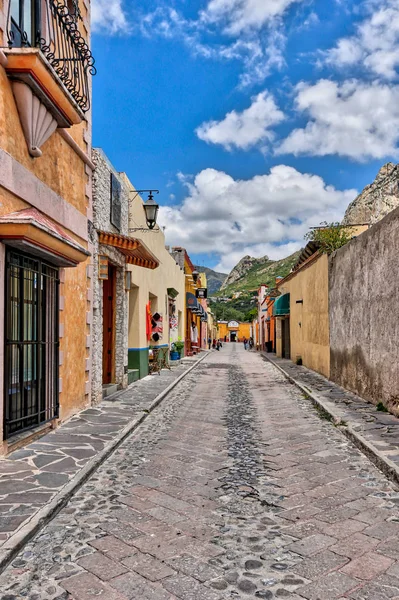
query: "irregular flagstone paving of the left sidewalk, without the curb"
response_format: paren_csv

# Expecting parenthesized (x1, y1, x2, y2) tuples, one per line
(0, 361, 197, 557)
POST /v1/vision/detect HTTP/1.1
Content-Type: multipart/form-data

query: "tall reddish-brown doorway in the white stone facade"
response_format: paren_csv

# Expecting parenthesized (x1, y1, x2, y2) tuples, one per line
(103, 264, 116, 385)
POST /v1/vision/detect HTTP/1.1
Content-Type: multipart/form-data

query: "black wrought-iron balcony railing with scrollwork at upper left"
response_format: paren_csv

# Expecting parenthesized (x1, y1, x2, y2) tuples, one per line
(8, 0, 97, 112)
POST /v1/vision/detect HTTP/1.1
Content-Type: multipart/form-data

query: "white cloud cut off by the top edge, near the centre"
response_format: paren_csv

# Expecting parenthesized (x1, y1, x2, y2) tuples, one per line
(201, 0, 302, 35)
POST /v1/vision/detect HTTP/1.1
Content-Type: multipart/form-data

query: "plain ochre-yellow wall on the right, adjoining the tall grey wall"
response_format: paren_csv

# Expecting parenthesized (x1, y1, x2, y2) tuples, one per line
(277, 254, 330, 377)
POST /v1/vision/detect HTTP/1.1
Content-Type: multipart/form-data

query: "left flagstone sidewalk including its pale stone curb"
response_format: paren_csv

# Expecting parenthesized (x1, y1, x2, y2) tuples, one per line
(0, 353, 207, 569)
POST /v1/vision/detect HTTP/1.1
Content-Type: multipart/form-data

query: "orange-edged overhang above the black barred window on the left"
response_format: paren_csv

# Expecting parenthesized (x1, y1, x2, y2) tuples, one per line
(0, 208, 90, 267)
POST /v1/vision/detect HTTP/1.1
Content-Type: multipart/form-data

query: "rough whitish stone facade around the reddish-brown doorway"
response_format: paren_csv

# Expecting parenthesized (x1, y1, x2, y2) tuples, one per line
(91, 149, 129, 404)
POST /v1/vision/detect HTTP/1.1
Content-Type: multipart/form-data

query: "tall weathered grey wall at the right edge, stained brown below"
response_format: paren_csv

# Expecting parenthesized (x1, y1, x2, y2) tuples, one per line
(329, 209, 399, 415)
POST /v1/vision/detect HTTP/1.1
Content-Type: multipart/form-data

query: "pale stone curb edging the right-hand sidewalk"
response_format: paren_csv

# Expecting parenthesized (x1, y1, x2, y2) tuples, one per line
(261, 354, 399, 484)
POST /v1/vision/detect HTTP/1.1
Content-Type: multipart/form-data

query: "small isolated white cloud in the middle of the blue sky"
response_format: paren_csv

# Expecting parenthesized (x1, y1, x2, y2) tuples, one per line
(196, 91, 284, 150)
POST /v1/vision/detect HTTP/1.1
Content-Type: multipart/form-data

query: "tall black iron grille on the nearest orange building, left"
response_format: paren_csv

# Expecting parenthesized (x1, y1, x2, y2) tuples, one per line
(4, 251, 59, 439)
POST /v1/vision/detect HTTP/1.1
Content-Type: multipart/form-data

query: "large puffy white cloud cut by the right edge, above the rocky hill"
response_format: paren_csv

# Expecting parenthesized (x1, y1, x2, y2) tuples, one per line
(276, 79, 399, 161)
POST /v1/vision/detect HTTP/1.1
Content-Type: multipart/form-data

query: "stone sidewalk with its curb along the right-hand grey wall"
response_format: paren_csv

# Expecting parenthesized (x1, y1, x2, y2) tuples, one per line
(261, 352, 399, 483)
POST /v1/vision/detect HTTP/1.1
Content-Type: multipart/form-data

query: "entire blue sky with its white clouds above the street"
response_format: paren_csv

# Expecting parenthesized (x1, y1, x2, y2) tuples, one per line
(92, 0, 399, 271)
